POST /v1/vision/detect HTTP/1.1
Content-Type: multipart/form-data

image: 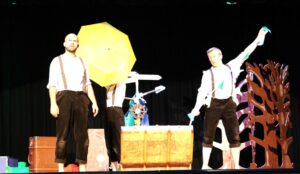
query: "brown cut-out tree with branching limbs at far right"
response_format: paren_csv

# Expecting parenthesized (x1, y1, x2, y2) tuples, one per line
(246, 60, 293, 168)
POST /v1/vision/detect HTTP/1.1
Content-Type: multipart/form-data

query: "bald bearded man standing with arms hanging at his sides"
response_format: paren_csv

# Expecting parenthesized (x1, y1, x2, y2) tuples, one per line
(47, 33, 99, 172)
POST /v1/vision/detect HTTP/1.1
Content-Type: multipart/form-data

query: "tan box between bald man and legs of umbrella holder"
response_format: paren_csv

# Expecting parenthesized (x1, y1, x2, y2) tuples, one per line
(86, 129, 109, 171)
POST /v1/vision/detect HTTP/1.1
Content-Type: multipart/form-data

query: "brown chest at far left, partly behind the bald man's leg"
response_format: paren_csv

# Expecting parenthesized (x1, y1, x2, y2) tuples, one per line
(28, 136, 58, 172)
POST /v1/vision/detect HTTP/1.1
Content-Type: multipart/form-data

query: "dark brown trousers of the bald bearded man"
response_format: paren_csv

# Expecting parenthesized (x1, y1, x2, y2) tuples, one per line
(55, 90, 90, 164)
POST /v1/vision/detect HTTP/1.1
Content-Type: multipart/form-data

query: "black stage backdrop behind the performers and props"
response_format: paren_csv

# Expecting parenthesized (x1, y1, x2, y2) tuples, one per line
(0, 0, 300, 168)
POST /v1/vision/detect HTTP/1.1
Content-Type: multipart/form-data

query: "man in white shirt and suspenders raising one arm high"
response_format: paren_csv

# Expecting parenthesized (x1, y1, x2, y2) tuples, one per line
(188, 27, 270, 169)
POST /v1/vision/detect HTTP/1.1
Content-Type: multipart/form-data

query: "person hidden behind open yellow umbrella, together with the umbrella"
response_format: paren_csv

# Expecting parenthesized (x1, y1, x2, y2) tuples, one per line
(77, 22, 136, 171)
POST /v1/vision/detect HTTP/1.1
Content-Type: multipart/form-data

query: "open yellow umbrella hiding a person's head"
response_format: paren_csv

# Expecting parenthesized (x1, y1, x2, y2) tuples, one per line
(76, 22, 136, 87)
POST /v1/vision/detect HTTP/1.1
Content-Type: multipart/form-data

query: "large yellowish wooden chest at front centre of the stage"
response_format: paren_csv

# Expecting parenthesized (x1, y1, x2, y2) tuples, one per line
(121, 126, 194, 170)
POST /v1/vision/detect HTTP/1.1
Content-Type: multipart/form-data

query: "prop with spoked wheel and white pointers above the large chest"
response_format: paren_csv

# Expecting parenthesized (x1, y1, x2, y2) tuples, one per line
(125, 72, 166, 126)
